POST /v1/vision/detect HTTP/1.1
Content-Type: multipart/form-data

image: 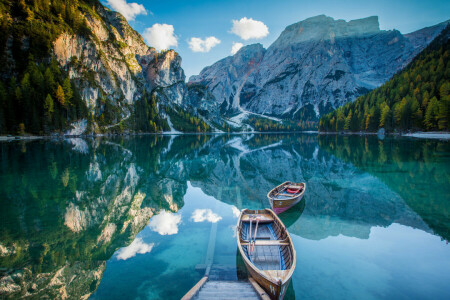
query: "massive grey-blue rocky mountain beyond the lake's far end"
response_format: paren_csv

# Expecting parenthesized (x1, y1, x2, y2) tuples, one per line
(190, 15, 445, 119)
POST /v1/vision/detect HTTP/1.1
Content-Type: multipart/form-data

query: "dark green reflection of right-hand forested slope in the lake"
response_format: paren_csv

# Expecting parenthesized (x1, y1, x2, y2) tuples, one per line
(319, 136, 450, 241)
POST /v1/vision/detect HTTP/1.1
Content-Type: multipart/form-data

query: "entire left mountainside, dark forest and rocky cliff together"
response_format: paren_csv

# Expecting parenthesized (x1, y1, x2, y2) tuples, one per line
(0, 0, 209, 134)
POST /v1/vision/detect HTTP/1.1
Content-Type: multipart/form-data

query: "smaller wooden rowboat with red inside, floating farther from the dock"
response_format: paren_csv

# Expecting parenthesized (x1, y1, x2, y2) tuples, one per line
(267, 181, 306, 214)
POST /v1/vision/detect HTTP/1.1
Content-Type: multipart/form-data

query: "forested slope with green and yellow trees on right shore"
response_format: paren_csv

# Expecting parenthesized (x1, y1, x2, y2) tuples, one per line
(319, 26, 450, 132)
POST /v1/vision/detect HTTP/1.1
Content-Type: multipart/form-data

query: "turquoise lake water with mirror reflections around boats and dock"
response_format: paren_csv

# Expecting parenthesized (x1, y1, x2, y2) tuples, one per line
(0, 134, 450, 299)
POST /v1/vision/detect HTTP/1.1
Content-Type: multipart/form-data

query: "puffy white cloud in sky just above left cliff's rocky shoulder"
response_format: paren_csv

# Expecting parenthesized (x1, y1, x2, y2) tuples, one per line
(142, 23, 178, 51)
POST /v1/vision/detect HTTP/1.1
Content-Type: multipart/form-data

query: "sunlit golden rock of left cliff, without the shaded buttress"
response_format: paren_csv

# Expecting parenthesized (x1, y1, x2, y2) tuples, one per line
(53, 6, 148, 109)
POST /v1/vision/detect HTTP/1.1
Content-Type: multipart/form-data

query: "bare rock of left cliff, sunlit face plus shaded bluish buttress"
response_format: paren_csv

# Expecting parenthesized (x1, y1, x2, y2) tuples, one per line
(53, 5, 195, 131)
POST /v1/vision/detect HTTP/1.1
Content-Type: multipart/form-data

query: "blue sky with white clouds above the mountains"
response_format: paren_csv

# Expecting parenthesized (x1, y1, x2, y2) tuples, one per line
(101, 0, 450, 80)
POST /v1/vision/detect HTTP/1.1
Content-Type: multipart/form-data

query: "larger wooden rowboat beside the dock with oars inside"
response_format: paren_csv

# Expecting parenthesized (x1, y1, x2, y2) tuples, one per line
(236, 209, 297, 299)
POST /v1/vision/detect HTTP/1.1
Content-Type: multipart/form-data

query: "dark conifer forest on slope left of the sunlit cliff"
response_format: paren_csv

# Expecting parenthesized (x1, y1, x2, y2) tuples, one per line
(0, 0, 98, 133)
